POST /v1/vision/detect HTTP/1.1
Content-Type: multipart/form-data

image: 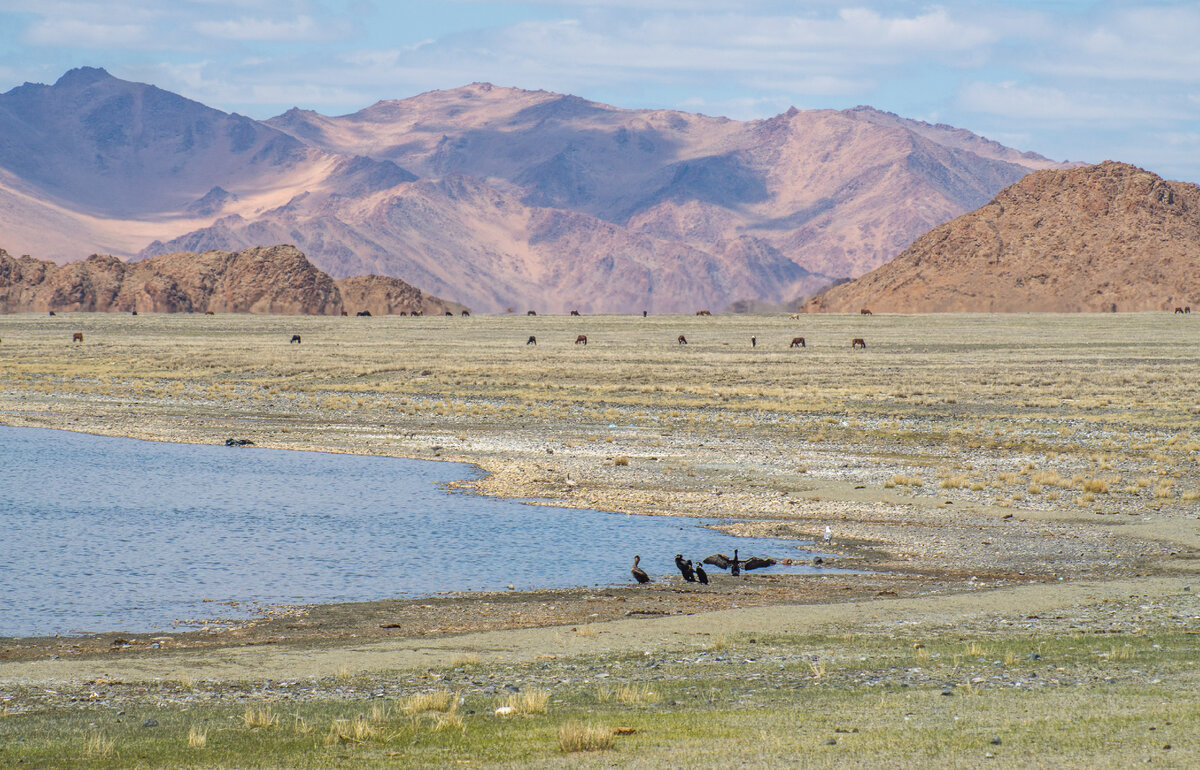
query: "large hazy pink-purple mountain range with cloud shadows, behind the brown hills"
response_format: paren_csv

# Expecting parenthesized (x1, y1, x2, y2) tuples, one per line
(0, 67, 1080, 312)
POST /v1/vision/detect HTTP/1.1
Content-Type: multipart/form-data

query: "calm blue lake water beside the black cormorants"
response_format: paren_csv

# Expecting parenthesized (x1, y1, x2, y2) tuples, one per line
(0, 427, 830, 636)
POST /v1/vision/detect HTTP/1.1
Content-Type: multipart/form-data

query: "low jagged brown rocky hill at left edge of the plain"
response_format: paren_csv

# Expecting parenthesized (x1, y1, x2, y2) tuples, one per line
(0, 246, 461, 315)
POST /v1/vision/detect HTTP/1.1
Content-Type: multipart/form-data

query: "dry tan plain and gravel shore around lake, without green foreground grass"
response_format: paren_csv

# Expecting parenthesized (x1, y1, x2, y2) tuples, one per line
(0, 314, 1200, 685)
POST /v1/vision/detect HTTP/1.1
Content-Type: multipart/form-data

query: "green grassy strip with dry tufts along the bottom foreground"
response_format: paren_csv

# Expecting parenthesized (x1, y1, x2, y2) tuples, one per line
(0, 633, 1200, 768)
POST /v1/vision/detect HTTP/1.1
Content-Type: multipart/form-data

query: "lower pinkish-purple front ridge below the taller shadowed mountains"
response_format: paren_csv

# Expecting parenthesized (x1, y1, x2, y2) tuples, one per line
(136, 175, 826, 313)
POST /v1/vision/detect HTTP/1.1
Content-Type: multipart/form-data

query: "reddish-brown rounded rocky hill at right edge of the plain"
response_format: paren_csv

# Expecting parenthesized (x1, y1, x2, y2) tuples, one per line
(806, 161, 1200, 313)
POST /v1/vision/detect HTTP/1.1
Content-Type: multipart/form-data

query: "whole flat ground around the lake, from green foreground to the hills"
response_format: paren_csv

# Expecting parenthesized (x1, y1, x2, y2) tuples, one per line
(0, 313, 1200, 766)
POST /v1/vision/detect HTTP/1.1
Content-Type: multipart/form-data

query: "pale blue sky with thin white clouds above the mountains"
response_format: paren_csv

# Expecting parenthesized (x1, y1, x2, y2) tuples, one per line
(0, 0, 1200, 182)
